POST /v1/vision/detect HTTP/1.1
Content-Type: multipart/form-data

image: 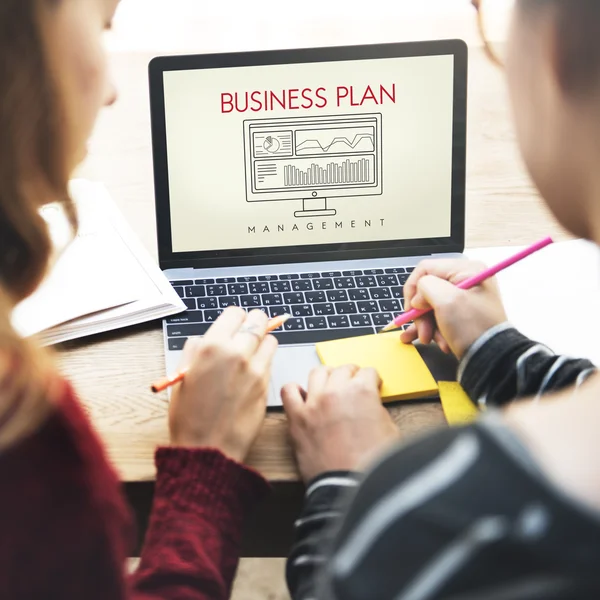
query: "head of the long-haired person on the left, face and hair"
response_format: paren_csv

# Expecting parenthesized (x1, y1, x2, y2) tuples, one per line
(0, 0, 118, 303)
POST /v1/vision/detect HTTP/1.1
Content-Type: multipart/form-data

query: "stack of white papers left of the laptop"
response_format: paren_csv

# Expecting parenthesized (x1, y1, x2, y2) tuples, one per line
(12, 180, 185, 345)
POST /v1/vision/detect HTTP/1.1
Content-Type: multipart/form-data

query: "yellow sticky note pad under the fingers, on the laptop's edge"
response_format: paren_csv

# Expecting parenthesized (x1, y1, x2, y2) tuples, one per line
(317, 333, 438, 402)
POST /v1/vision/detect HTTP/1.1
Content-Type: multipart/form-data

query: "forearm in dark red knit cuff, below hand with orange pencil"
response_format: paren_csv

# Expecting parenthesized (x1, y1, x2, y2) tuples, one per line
(130, 448, 268, 600)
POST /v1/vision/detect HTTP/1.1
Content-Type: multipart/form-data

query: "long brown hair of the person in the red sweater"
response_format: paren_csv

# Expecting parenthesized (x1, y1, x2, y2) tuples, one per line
(0, 0, 76, 448)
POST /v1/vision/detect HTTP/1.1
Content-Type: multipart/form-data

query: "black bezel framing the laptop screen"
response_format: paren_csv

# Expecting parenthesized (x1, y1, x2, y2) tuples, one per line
(149, 40, 468, 269)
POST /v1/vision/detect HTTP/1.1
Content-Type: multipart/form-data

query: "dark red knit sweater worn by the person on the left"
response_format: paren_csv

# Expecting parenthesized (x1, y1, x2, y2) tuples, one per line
(0, 385, 268, 600)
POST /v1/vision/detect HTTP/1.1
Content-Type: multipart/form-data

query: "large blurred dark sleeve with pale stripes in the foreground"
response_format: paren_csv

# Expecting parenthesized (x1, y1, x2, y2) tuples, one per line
(288, 424, 600, 600)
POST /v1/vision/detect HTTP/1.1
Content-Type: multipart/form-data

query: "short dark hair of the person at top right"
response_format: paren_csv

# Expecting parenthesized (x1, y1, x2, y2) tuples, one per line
(519, 0, 600, 95)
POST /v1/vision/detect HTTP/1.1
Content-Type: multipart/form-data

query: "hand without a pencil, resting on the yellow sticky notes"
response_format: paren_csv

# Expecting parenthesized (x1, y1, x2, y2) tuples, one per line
(281, 365, 398, 481)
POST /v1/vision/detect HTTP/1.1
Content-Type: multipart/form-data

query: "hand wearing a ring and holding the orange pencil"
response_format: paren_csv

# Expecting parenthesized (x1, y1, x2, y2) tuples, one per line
(169, 307, 277, 462)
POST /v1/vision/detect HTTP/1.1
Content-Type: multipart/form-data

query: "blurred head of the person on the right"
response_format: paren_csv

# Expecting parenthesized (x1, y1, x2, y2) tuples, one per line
(506, 0, 600, 241)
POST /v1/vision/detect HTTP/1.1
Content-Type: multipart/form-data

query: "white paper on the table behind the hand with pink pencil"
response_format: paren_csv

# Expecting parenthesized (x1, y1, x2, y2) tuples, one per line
(465, 240, 600, 365)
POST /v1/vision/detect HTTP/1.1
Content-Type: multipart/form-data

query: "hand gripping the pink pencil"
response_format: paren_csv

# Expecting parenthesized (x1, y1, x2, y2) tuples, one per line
(401, 259, 506, 359)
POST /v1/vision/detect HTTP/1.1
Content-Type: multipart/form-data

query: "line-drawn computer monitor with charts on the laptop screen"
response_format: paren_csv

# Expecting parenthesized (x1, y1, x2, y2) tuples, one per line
(244, 113, 383, 217)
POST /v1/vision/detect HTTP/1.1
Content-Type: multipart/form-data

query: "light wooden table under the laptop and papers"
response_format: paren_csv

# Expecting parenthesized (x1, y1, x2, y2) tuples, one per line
(59, 44, 567, 555)
